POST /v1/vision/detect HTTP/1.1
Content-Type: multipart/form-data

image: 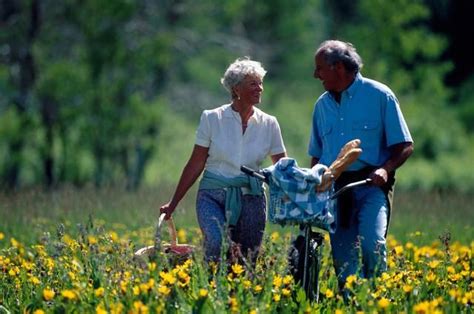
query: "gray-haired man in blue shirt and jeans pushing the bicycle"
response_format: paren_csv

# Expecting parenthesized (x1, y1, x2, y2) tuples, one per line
(308, 40, 413, 289)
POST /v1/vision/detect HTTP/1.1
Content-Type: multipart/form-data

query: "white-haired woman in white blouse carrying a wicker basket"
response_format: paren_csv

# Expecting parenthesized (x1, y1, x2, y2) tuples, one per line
(160, 58, 286, 261)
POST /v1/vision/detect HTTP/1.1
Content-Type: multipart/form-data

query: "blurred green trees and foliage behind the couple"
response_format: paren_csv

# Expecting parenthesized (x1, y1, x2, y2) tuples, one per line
(0, 0, 474, 193)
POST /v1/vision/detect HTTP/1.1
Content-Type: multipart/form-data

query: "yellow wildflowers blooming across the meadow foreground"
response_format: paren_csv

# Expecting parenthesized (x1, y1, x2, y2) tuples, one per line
(0, 217, 474, 313)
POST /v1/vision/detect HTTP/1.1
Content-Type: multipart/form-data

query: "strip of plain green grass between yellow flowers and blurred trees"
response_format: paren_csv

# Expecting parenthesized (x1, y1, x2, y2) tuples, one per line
(0, 186, 474, 248)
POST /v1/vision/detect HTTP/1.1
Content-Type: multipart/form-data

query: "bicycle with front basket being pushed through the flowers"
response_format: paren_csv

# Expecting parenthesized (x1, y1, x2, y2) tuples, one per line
(240, 163, 371, 302)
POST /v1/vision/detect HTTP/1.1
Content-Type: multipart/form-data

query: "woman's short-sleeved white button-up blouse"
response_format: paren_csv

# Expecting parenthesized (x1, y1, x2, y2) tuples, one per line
(196, 104, 286, 177)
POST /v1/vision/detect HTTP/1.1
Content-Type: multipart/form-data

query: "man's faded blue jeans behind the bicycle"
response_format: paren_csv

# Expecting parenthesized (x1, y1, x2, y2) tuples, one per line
(330, 185, 389, 288)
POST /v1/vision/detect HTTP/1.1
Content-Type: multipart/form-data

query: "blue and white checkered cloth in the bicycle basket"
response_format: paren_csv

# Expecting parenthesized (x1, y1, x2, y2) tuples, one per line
(263, 158, 336, 232)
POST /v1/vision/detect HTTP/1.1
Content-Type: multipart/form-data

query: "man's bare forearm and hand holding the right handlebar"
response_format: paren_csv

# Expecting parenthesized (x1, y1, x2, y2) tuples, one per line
(370, 142, 414, 186)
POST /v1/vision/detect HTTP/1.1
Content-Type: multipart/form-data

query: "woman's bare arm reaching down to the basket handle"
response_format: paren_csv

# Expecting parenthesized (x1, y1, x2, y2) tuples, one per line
(160, 145, 209, 219)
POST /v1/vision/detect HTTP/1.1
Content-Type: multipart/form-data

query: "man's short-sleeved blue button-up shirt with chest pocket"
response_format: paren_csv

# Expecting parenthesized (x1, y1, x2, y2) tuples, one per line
(308, 73, 413, 170)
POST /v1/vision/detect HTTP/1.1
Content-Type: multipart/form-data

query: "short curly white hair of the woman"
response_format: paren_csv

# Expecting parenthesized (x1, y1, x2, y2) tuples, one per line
(221, 57, 267, 96)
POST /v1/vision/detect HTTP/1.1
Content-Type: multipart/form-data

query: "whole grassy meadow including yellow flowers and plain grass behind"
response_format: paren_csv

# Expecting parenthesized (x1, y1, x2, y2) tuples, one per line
(0, 187, 474, 313)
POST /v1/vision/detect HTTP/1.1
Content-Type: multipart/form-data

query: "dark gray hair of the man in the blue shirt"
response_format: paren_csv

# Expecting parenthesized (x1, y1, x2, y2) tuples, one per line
(316, 40, 363, 73)
